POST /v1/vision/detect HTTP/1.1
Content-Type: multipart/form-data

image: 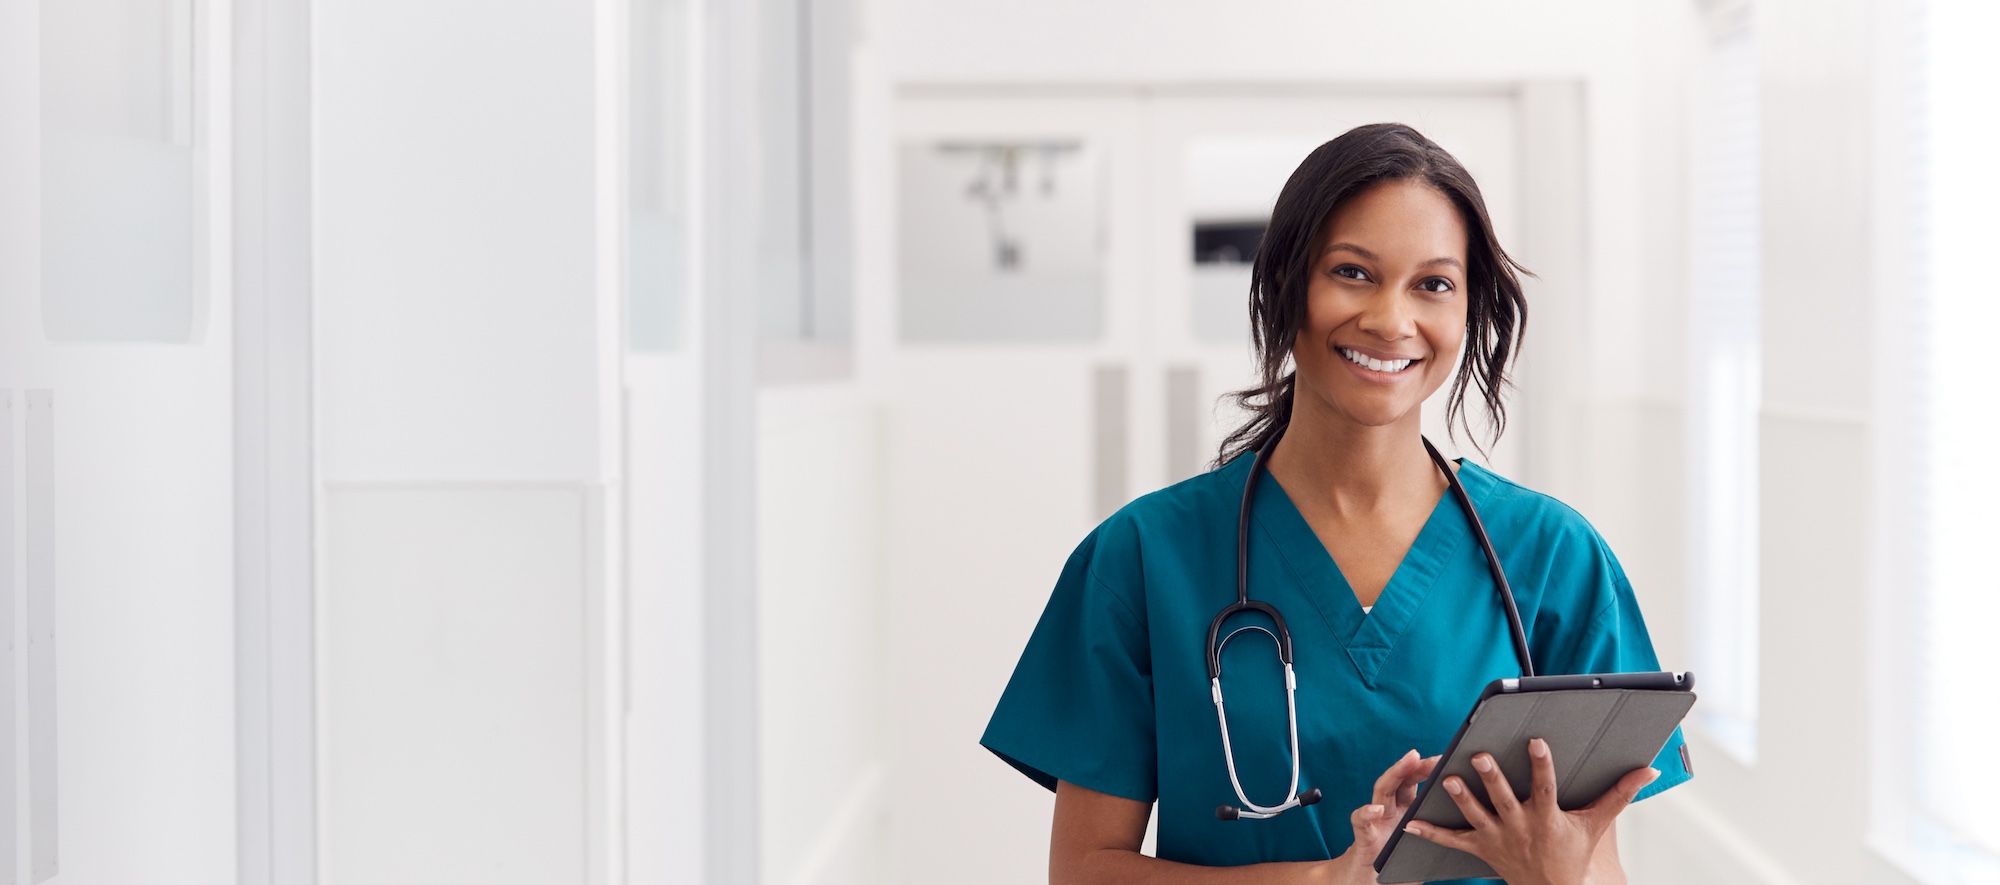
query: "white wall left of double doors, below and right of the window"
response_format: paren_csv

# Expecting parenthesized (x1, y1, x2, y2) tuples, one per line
(756, 22, 898, 885)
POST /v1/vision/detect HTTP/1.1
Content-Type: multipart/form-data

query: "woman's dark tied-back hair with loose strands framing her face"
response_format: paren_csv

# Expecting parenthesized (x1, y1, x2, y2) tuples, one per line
(1216, 122, 1532, 467)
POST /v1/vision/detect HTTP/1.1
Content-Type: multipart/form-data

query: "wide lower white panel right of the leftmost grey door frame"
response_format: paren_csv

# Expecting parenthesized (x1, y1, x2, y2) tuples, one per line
(320, 485, 590, 885)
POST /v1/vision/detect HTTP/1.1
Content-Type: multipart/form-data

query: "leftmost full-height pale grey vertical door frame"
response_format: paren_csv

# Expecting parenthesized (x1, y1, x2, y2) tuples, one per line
(232, 0, 318, 885)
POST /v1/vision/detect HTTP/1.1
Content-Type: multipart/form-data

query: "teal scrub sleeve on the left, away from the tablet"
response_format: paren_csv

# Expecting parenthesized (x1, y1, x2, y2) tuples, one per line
(980, 527, 1158, 803)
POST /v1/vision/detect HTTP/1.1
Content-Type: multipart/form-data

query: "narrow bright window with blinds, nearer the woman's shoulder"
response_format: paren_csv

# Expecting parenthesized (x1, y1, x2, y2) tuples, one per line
(1688, 26, 1764, 763)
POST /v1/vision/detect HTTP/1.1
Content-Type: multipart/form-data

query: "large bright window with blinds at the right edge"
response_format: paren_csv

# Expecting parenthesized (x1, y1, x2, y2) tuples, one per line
(1910, 4, 2000, 883)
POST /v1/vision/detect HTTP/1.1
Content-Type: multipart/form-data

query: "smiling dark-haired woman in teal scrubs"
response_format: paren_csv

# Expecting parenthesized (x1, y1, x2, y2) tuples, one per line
(980, 124, 1690, 885)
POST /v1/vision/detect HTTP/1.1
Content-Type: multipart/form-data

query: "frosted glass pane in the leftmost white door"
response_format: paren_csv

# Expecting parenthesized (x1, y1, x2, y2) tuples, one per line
(40, 0, 198, 340)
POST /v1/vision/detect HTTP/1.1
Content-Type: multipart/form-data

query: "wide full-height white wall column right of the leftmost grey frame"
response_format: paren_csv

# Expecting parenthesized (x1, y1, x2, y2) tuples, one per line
(314, 0, 624, 885)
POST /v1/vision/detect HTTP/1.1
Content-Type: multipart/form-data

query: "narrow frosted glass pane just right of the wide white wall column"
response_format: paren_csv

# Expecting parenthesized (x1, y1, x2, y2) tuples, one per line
(626, 0, 690, 350)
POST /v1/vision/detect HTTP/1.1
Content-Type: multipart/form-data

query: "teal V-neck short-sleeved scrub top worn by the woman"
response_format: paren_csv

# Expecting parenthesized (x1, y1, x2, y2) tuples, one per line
(980, 457, 1690, 880)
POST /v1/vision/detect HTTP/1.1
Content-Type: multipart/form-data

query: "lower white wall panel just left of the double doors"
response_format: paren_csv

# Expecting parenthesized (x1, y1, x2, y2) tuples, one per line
(758, 386, 890, 885)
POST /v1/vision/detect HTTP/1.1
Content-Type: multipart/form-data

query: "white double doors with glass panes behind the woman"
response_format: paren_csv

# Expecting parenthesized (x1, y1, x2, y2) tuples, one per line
(880, 88, 1520, 883)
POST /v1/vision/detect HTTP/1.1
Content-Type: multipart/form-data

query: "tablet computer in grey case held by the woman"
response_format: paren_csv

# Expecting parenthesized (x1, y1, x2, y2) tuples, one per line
(1374, 673, 1694, 883)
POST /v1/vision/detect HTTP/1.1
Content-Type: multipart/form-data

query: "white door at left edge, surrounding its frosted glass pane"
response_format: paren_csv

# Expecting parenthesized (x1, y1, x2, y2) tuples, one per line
(0, 0, 236, 885)
